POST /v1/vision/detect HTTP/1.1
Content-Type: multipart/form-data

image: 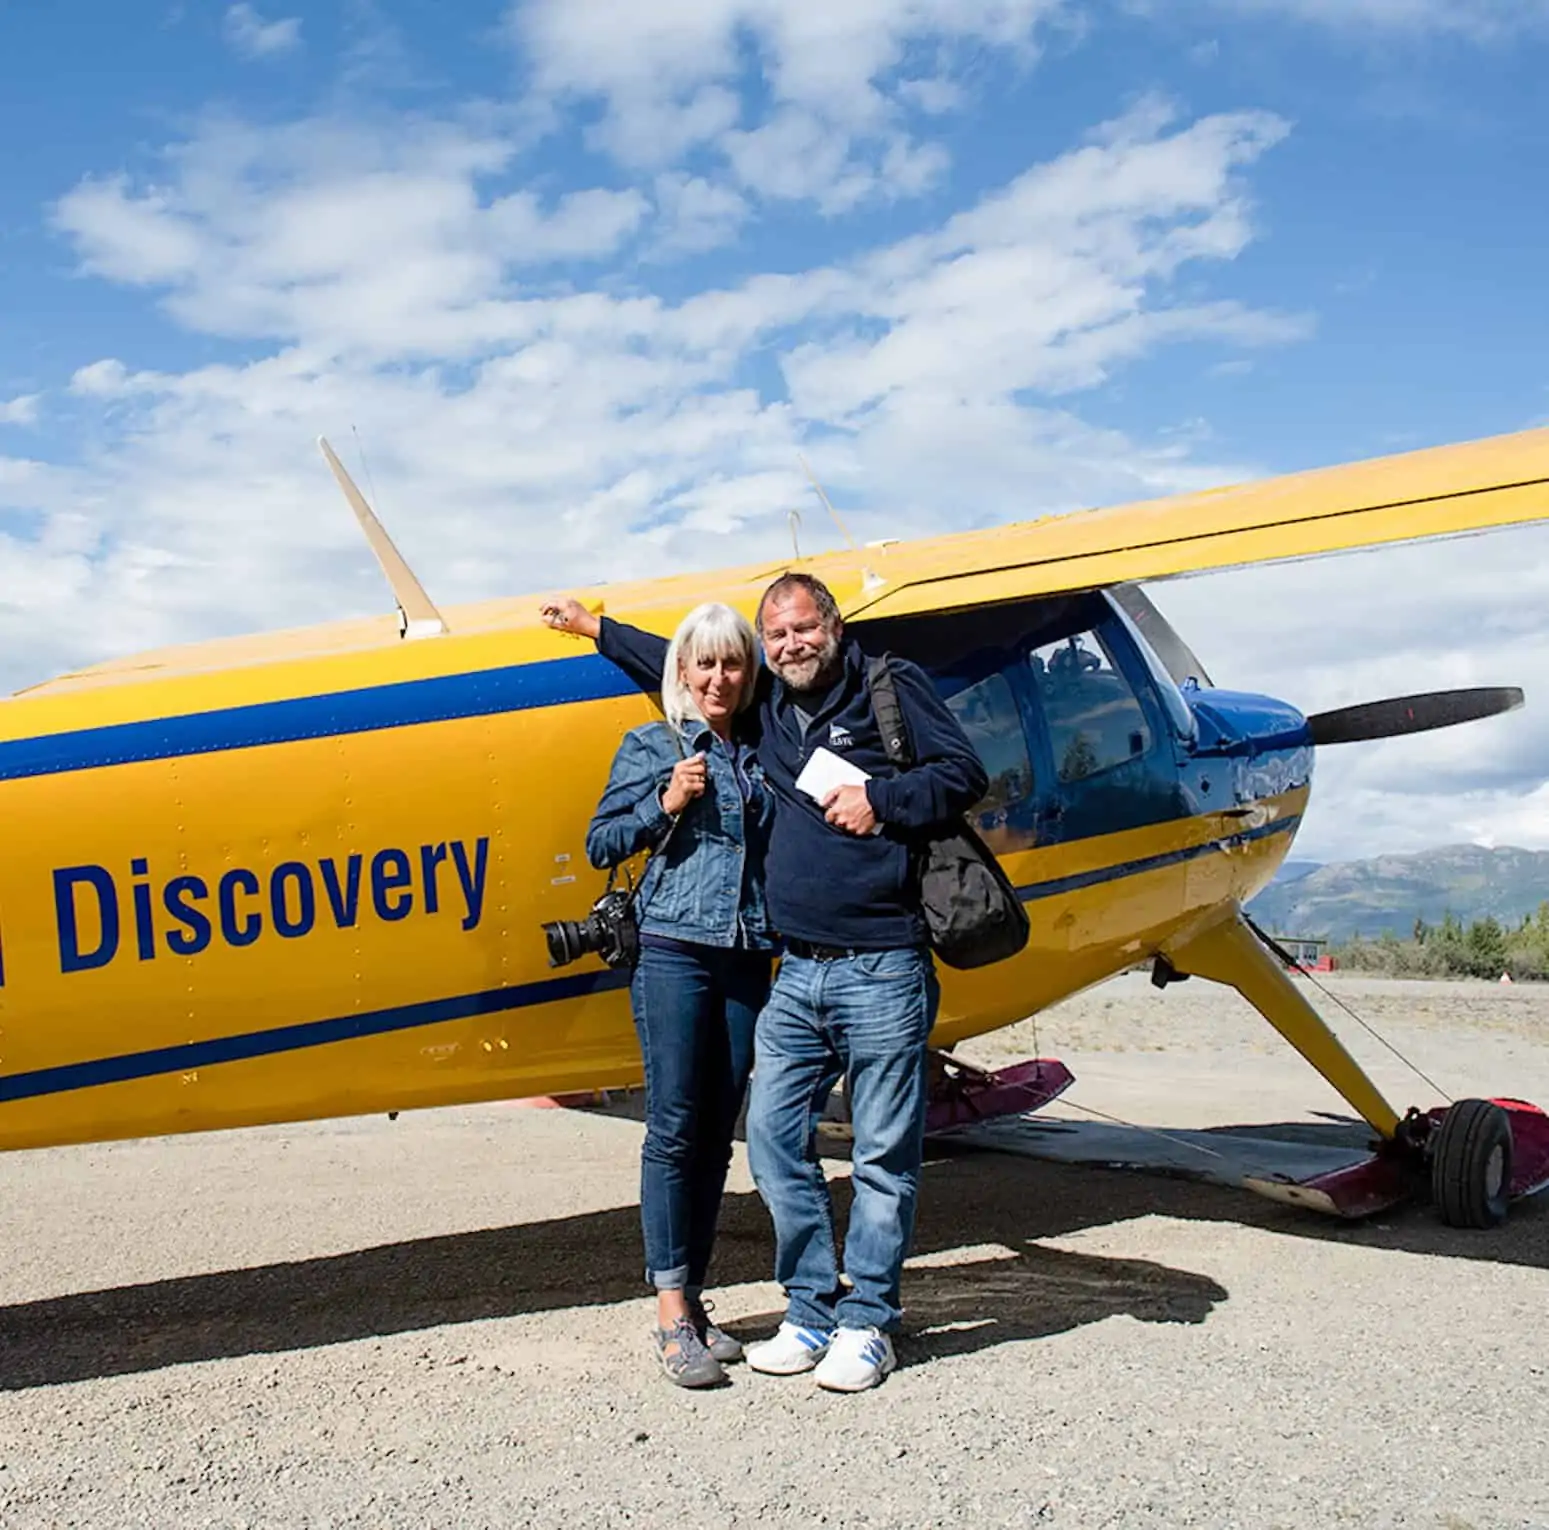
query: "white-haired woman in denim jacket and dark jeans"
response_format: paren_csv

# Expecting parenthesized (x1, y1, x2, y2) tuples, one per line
(544, 601, 775, 1386)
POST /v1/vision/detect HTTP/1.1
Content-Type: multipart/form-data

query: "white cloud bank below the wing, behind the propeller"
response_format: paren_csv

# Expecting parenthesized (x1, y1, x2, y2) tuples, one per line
(1152, 527, 1549, 861)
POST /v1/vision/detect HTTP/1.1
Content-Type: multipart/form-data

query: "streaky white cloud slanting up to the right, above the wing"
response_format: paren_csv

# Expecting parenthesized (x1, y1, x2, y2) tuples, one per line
(785, 107, 1303, 421)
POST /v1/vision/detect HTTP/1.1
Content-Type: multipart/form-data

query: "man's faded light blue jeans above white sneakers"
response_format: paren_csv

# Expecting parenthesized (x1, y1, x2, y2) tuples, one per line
(748, 949, 940, 1332)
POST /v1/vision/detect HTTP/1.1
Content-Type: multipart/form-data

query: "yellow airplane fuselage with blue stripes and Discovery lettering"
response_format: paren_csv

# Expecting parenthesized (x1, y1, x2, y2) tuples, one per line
(0, 593, 1312, 1148)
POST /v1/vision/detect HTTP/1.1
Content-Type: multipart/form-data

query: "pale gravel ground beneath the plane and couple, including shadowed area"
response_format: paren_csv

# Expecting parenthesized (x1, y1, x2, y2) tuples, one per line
(0, 977, 1549, 1530)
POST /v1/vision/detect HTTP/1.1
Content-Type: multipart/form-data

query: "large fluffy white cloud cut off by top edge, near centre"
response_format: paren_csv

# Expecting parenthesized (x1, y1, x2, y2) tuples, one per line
(508, 0, 1070, 212)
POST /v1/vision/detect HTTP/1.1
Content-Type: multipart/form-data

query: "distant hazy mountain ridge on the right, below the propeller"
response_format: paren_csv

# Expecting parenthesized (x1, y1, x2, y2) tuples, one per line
(1248, 844, 1549, 940)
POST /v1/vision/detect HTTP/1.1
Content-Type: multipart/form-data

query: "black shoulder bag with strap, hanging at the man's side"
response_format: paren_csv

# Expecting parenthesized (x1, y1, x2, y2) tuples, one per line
(866, 654, 1032, 968)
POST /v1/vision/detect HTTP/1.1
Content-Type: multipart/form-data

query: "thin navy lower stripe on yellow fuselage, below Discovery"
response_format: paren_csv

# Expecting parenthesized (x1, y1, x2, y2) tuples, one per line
(0, 816, 1301, 1103)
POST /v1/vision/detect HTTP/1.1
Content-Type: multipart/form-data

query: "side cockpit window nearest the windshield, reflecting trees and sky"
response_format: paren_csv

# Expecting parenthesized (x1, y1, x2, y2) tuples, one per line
(1029, 632, 1151, 782)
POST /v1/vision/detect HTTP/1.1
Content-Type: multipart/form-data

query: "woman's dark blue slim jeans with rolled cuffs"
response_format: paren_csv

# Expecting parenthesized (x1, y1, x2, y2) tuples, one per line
(629, 946, 771, 1295)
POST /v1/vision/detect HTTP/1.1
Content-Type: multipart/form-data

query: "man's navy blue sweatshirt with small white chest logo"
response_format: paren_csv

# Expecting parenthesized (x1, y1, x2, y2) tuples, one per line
(596, 616, 988, 951)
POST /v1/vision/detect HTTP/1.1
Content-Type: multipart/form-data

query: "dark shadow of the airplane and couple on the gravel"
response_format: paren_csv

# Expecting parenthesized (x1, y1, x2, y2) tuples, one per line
(0, 1121, 1549, 1391)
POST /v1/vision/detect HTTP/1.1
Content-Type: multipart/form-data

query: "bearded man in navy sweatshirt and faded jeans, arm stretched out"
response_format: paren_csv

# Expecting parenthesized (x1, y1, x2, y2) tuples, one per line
(544, 573, 987, 1392)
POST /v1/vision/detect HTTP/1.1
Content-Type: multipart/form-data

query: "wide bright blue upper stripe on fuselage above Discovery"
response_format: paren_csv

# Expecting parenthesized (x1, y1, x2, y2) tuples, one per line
(0, 654, 638, 780)
